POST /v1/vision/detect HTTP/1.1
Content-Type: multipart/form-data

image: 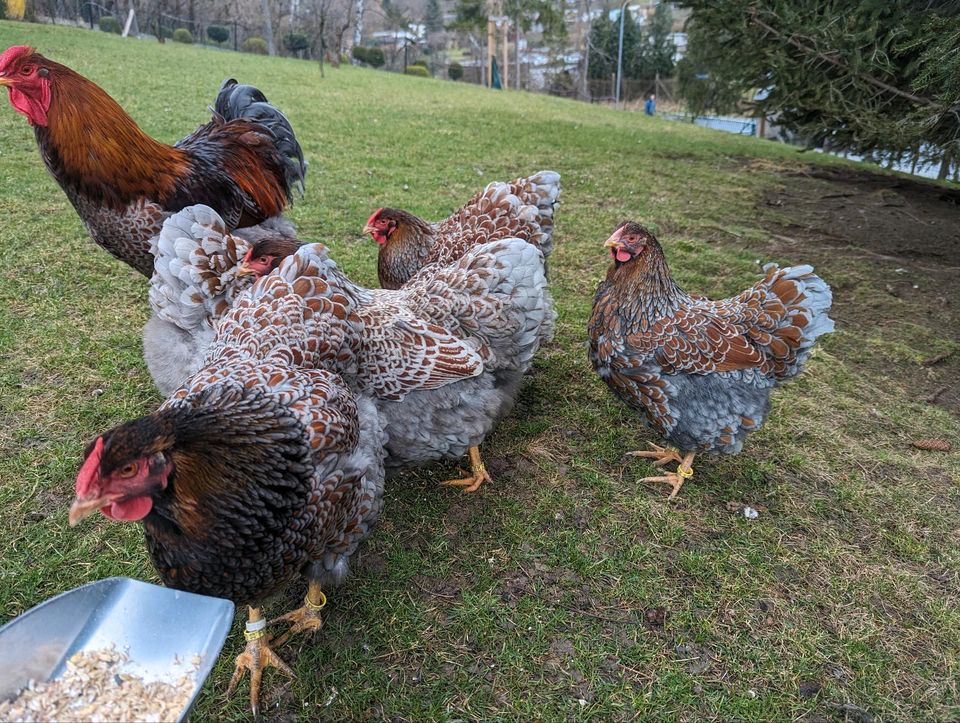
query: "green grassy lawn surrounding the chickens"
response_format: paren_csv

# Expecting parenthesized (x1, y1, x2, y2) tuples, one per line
(0, 22, 960, 720)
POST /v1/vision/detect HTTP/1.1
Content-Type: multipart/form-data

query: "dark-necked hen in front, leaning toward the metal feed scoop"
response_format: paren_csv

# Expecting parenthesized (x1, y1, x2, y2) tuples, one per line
(70, 242, 386, 713)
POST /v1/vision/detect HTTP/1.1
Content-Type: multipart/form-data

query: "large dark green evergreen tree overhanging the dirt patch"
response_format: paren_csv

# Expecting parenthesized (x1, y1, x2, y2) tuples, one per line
(680, 0, 960, 169)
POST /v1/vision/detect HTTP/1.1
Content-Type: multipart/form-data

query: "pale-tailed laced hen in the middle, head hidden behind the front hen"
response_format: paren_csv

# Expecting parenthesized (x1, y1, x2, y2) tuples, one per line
(240, 226, 555, 492)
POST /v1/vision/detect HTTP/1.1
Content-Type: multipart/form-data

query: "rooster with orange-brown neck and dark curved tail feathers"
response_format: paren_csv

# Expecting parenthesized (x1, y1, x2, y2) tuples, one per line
(0, 45, 306, 277)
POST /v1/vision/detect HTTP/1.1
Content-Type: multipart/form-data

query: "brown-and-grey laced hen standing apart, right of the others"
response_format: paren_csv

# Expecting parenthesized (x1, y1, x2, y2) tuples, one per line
(589, 222, 833, 499)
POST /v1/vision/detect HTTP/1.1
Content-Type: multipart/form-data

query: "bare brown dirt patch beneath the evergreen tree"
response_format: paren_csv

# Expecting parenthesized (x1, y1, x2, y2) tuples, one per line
(758, 167, 960, 415)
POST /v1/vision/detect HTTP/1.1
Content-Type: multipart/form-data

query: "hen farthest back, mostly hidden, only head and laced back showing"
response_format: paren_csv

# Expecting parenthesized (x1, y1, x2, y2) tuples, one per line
(363, 171, 560, 289)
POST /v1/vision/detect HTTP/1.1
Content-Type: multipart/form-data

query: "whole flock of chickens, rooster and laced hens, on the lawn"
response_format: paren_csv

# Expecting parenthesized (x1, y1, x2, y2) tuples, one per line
(0, 46, 833, 712)
